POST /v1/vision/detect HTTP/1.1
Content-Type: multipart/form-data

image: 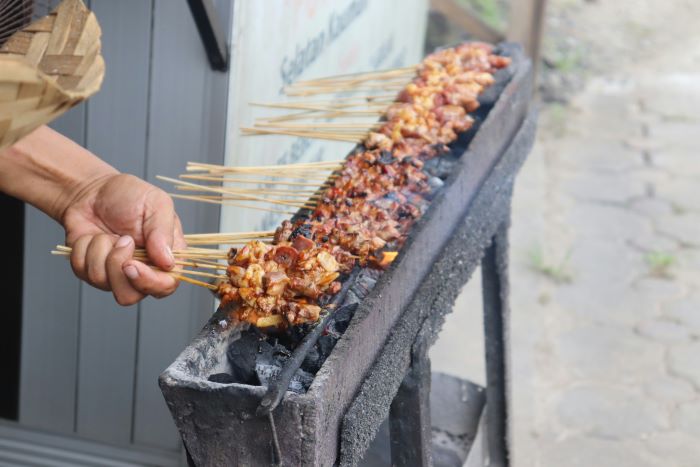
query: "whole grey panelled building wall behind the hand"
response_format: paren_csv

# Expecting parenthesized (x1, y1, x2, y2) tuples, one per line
(6, 0, 231, 459)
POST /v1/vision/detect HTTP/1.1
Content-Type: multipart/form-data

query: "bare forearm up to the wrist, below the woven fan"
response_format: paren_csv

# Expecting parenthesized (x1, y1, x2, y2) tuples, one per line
(0, 126, 118, 222)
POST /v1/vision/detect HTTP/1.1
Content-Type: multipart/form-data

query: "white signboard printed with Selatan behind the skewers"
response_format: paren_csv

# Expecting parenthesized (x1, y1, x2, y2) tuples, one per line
(221, 0, 428, 232)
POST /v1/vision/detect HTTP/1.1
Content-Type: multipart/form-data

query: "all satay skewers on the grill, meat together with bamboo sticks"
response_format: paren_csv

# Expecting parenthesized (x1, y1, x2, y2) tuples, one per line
(57, 43, 509, 327)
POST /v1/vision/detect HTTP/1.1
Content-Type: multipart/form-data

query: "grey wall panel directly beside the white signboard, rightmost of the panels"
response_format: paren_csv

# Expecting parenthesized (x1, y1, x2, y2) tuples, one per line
(134, 0, 230, 449)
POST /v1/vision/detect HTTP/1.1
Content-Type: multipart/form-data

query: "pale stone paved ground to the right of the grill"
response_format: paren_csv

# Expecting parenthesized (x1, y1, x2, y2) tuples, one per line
(432, 0, 700, 467)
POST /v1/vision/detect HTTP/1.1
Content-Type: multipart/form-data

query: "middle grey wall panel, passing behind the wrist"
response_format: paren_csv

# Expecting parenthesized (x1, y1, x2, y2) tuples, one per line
(76, 0, 152, 445)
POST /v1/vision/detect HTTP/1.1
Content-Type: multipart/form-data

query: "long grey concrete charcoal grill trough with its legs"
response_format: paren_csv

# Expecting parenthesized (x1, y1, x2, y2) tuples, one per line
(160, 44, 536, 466)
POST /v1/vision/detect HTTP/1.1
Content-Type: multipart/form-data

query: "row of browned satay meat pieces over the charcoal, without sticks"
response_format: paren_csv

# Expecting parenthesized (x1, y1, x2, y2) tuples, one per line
(218, 43, 510, 326)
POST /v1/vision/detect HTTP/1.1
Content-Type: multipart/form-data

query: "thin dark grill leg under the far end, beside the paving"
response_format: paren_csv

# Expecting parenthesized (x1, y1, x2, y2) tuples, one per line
(481, 223, 510, 467)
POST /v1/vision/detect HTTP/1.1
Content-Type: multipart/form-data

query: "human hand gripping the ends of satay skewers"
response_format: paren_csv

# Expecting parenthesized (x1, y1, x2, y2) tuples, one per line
(59, 171, 186, 306)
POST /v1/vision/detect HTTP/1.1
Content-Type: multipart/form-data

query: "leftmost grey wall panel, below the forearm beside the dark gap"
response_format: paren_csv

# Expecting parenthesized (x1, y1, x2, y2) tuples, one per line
(19, 105, 85, 433)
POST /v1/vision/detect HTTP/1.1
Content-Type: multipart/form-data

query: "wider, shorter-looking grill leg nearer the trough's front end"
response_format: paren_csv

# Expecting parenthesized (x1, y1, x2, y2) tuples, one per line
(389, 333, 432, 467)
